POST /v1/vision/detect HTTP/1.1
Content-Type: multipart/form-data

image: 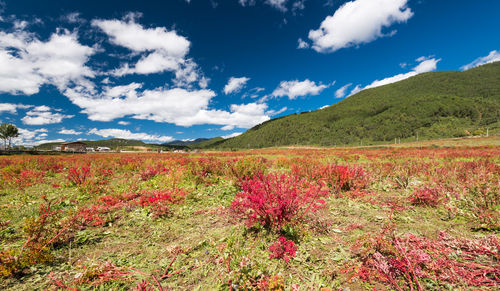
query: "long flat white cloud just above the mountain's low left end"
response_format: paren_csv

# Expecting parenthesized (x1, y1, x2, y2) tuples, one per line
(64, 83, 269, 128)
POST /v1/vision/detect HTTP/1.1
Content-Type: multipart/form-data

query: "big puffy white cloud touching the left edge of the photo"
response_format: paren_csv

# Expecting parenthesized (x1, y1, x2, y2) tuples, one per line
(0, 30, 95, 95)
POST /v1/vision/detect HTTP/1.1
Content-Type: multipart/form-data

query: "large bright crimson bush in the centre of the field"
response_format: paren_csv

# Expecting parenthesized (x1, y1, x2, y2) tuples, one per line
(231, 174, 327, 230)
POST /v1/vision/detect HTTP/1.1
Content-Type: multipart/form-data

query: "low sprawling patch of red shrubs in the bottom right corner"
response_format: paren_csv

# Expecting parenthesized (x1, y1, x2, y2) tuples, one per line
(357, 232, 500, 290)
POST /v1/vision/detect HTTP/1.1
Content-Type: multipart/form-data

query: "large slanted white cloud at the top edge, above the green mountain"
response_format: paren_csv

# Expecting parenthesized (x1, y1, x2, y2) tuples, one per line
(309, 0, 413, 52)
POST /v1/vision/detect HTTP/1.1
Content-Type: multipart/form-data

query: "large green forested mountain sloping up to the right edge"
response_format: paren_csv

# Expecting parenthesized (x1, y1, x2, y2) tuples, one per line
(209, 62, 500, 148)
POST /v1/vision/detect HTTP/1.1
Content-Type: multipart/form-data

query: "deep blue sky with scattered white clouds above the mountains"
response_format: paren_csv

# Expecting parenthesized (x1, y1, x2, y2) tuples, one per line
(0, 0, 500, 145)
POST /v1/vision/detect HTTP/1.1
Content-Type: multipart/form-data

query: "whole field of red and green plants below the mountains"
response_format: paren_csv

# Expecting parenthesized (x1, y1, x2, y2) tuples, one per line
(0, 147, 500, 290)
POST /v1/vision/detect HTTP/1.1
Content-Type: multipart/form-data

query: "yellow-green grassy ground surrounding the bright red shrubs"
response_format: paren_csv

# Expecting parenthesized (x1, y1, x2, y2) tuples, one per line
(0, 145, 500, 290)
